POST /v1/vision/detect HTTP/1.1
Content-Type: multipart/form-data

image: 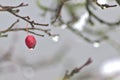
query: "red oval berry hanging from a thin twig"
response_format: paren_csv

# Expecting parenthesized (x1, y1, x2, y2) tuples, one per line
(25, 35, 36, 49)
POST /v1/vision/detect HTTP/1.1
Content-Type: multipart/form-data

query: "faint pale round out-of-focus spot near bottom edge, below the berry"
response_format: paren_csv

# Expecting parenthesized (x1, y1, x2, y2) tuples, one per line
(23, 67, 35, 79)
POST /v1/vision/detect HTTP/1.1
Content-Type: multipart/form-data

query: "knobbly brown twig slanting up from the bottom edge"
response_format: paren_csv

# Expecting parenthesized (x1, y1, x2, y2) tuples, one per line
(62, 58, 92, 80)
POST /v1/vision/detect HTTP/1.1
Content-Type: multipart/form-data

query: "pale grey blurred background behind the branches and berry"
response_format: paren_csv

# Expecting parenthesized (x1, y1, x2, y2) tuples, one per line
(0, 0, 120, 80)
